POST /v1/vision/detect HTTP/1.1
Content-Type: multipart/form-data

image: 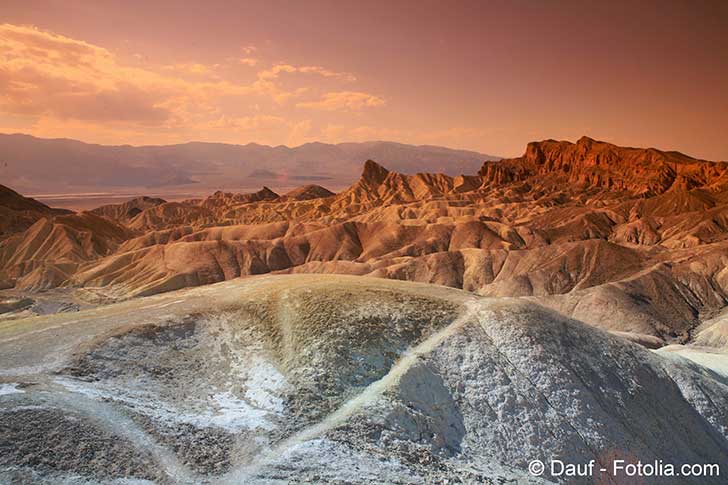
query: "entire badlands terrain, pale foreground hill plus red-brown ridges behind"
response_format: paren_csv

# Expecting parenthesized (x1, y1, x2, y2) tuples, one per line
(0, 137, 728, 484)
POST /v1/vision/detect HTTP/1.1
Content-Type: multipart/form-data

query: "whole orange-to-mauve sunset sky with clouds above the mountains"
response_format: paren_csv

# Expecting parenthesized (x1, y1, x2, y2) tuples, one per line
(0, 0, 728, 160)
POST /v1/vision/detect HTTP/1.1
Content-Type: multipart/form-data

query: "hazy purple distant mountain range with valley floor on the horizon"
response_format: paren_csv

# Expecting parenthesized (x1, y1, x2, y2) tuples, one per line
(0, 134, 497, 193)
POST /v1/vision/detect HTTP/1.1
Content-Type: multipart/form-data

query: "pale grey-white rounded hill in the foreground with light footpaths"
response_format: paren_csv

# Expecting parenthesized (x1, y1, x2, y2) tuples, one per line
(0, 275, 728, 484)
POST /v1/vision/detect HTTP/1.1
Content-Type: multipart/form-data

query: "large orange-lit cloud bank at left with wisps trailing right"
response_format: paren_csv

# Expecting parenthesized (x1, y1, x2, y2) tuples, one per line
(0, 24, 384, 144)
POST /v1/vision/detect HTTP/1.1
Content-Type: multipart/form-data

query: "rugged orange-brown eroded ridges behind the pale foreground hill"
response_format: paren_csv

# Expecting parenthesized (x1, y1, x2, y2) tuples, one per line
(0, 137, 728, 346)
